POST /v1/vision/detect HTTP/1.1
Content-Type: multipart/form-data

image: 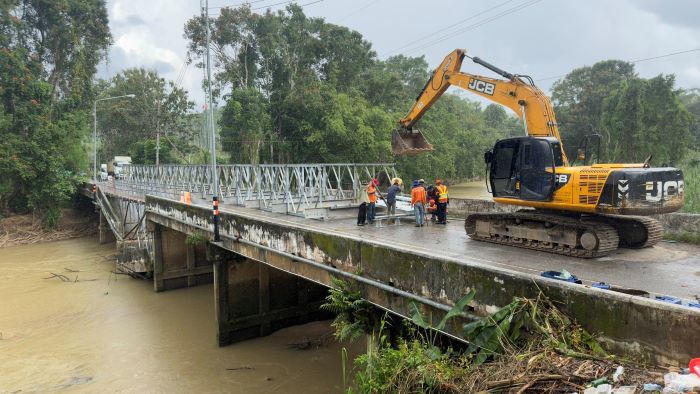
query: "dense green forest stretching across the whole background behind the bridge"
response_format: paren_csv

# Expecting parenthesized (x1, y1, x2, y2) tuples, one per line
(0, 0, 700, 225)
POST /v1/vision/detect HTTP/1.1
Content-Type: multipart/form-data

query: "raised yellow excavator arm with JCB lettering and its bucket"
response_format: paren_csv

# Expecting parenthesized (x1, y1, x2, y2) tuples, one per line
(392, 49, 568, 163)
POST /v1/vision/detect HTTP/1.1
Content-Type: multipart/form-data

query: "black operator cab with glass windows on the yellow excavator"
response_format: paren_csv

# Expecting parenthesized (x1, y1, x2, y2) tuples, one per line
(489, 137, 557, 201)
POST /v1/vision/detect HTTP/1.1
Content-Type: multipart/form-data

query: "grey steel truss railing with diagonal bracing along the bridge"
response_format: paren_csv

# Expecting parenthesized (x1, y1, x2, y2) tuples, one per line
(115, 163, 396, 213)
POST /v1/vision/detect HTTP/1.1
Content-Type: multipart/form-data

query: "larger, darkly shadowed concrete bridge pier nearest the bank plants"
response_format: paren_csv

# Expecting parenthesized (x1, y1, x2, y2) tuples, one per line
(207, 245, 330, 346)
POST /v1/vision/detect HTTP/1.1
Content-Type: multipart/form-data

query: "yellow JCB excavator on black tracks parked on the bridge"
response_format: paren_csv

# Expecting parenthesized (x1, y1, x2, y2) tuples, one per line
(392, 49, 683, 258)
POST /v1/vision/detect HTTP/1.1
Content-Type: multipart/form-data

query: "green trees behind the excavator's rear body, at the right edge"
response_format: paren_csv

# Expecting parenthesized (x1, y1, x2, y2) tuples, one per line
(552, 60, 700, 165)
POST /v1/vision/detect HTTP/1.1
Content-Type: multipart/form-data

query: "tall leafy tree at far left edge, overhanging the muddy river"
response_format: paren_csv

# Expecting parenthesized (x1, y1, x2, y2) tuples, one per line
(0, 0, 111, 226)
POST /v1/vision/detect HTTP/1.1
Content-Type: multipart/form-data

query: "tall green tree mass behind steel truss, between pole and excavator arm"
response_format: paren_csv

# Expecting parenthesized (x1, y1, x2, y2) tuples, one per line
(185, 5, 520, 181)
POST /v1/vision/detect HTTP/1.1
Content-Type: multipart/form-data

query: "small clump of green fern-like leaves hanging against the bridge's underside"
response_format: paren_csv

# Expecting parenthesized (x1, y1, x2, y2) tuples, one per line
(321, 278, 380, 341)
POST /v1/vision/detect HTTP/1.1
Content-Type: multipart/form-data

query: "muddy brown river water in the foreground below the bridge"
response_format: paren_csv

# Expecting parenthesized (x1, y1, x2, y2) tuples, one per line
(0, 238, 364, 393)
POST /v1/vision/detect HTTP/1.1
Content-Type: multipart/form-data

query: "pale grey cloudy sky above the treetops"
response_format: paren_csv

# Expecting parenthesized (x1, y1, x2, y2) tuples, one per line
(99, 0, 700, 106)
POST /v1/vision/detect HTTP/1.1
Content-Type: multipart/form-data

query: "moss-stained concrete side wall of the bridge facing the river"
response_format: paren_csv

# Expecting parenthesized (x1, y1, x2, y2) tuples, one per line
(146, 197, 700, 363)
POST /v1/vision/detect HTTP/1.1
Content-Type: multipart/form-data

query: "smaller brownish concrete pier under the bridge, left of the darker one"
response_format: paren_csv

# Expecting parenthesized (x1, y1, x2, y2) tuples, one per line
(153, 222, 213, 291)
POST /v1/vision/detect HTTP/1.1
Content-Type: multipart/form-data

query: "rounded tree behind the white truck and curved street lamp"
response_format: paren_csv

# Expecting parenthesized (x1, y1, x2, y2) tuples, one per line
(97, 68, 199, 163)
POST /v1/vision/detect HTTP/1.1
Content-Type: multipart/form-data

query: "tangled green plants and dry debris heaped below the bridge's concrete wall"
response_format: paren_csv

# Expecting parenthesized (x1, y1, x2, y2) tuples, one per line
(323, 280, 663, 393)
